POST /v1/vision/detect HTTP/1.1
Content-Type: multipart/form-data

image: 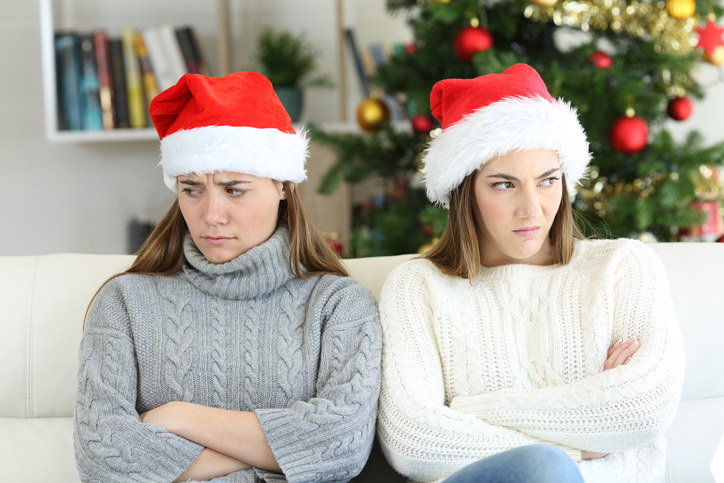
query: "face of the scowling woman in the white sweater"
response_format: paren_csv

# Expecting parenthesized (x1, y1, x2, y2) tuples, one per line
(473, 149, 563, 267)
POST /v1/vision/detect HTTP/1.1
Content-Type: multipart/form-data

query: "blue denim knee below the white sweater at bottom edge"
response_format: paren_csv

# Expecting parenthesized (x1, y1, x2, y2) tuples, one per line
(445, 444, 583, 483)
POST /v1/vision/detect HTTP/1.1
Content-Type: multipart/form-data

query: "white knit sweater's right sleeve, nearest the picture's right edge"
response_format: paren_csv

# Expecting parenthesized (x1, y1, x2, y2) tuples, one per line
(450, 242, 684, 453)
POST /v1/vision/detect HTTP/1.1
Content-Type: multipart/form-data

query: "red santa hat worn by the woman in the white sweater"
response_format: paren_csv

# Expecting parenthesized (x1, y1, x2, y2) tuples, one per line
(422, 64, 591, 208)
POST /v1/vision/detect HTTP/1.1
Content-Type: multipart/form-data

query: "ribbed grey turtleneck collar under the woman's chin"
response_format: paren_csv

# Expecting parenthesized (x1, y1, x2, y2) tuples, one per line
(183, 226, 295, 300)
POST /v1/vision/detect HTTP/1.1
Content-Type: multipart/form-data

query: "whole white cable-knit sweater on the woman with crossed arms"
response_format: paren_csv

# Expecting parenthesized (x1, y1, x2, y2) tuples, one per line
(378, 239, 684, 483)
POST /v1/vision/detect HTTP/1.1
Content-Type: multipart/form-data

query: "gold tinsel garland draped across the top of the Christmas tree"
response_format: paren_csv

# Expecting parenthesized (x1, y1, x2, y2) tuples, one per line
(525, 0, 698, 53)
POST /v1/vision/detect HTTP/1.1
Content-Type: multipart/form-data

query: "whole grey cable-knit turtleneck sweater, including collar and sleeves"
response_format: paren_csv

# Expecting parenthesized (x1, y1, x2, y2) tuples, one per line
(75, 228, 381, 482)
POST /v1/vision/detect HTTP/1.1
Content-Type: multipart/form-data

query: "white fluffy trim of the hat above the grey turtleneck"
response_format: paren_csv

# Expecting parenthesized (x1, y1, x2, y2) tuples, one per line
(160, 126, 309, 193)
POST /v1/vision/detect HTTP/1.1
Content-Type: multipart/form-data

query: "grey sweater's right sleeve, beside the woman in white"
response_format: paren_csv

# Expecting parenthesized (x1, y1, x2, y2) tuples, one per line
(256, 276, 381, 482)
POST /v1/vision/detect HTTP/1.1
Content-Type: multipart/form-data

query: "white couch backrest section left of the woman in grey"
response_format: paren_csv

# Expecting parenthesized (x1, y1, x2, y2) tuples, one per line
(0, 254, 133, 418)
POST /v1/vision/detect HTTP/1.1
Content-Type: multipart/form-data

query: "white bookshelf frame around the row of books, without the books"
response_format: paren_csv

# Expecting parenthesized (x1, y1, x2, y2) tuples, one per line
(39, 0, 230, 143)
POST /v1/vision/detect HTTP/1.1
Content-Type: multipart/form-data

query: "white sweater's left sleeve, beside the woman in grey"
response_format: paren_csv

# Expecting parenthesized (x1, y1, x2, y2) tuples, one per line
(378, 260, 580, 481)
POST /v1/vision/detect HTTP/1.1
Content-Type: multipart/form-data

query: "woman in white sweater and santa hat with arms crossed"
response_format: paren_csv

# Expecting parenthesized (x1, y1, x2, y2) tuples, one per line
(378, 64, 684, 483)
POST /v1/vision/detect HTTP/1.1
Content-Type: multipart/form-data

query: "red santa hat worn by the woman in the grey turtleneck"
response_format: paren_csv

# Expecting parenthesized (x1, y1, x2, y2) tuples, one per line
(150, 72, 309, 192)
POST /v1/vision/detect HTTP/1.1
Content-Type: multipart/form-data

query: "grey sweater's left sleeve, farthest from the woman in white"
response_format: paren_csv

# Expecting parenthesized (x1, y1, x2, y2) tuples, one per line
(74, 281, 202, 481)
